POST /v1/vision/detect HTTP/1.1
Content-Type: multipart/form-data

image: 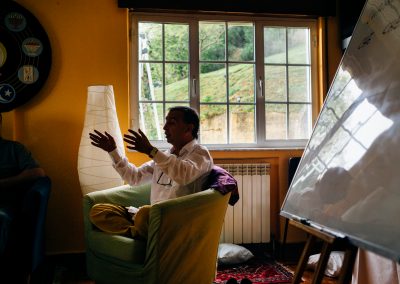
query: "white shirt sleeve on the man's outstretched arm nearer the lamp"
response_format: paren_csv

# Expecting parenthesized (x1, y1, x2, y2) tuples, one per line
(109, 149, 154, 185)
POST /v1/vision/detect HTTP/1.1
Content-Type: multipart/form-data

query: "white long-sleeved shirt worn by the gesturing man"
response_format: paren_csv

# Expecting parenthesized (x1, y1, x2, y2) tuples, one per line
(106, 139, 213, 204)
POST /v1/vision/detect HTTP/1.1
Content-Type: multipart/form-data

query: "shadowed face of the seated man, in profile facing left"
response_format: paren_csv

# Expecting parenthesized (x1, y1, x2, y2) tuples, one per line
(163, 111, 191, 146)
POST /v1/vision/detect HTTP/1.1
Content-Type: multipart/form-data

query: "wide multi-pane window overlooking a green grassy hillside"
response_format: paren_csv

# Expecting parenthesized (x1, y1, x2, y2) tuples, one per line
(131, 13, 317, 148)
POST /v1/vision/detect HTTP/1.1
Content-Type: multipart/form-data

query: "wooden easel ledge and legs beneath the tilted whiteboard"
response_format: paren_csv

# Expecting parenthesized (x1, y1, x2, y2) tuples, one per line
(289, 220, 357, 284)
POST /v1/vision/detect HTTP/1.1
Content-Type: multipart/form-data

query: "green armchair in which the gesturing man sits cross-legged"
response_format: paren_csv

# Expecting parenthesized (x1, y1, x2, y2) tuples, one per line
(83, 185, 231, 284)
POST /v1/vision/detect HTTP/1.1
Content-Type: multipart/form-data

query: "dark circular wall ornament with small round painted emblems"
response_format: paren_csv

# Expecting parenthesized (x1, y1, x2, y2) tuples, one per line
(0, 0, 51, 112)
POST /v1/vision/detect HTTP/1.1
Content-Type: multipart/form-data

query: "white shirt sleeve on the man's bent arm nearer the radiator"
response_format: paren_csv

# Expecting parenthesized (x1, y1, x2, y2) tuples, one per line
(153, 145, 213, 185)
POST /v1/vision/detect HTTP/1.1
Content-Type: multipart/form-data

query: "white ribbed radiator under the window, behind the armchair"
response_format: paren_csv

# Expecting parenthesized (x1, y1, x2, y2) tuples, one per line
(218, 163, 271, 244)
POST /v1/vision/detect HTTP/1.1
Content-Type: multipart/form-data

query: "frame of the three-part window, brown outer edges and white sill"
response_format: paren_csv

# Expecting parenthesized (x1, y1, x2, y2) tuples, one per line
(129, 12, 319, 150)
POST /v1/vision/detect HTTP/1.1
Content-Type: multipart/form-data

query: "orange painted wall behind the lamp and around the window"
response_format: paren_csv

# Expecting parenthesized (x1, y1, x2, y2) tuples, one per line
(3, 0, 338, 254)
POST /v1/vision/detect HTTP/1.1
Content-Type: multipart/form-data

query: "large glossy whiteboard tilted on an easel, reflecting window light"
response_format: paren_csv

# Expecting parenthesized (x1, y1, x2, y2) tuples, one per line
(281, 0, 400, 261)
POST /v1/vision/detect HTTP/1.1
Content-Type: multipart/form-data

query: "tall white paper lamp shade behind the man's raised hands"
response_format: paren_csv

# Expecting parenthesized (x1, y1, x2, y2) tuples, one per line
(78, 85, 125, 195)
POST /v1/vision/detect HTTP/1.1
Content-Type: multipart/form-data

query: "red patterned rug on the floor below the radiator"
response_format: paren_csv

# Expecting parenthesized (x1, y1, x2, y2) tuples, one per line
(213, 257, 293, 284)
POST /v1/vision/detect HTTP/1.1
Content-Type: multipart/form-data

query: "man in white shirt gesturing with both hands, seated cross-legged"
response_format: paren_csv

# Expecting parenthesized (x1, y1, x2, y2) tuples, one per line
(90, 106, 213, 236)
